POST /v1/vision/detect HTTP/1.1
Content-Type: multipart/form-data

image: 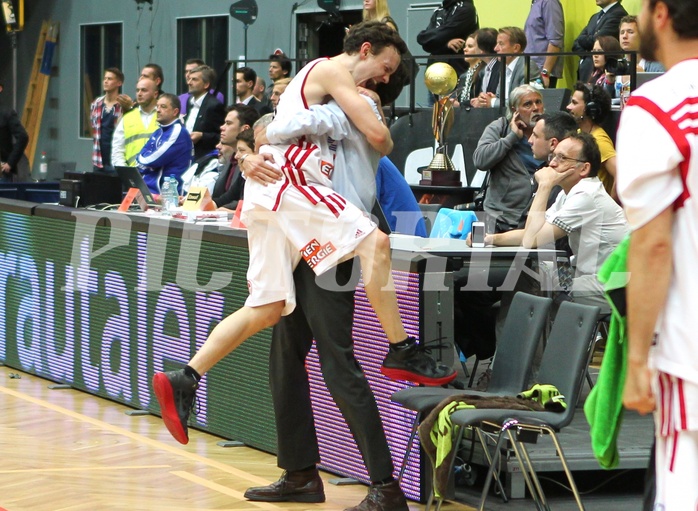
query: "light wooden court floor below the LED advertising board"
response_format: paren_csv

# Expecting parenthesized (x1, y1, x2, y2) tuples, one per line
(0, 366, 472, 511)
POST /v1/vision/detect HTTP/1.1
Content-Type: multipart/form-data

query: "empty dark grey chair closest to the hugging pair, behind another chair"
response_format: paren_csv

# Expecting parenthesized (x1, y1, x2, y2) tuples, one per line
(390, 293, 552, 480)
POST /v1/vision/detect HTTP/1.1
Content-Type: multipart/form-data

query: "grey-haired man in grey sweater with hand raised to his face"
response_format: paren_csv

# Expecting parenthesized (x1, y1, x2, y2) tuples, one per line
(473, 85, 543, 232)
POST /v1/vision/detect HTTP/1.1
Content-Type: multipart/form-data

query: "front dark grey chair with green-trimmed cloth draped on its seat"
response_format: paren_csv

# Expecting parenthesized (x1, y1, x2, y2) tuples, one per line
(440, 302, 599, 511)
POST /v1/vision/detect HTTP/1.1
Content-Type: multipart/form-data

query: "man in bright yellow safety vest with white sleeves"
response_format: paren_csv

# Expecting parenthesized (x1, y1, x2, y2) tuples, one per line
(111, 78, 158, 167)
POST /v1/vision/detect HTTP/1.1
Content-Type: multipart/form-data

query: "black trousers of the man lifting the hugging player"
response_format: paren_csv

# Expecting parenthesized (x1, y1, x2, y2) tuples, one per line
(269, 260, 393, 481)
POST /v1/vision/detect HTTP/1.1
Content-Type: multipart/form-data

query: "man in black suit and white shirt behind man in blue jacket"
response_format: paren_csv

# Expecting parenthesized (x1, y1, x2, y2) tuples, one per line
(184, 66, 225, 160)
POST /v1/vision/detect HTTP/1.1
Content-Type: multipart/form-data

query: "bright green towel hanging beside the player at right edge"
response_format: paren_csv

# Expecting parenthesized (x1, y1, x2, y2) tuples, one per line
(584, 237, 630, 469)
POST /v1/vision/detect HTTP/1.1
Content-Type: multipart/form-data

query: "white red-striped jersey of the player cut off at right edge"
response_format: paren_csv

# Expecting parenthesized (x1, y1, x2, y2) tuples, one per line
(616, 59, 698, 383)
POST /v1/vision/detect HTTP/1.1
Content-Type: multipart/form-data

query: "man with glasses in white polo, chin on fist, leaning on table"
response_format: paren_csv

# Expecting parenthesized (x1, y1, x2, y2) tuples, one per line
(478, 133, 628, 308)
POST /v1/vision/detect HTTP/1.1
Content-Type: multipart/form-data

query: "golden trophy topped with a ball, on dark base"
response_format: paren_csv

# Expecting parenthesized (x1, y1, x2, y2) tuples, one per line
(419, 62, 462, 186)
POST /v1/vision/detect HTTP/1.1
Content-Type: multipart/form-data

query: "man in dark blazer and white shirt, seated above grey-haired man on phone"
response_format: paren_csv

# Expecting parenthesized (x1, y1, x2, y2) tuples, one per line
(475, 27, 540, 108)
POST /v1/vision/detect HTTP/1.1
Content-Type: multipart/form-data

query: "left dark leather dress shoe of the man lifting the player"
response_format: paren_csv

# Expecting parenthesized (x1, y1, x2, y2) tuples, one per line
(245, 468, 325, 502)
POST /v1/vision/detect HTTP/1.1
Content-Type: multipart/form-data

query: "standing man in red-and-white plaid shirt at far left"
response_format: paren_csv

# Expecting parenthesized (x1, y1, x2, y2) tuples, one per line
(90, 67, 124, 174)
